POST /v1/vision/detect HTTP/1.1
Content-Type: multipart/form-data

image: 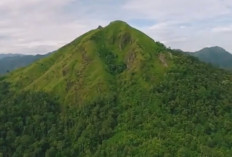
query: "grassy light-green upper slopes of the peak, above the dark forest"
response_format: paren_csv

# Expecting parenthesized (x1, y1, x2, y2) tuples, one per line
(8, 21, 170, 104)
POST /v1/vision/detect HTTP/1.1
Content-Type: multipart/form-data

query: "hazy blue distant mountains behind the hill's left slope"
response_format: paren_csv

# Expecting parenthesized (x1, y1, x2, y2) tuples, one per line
(0, 54, 48, 74)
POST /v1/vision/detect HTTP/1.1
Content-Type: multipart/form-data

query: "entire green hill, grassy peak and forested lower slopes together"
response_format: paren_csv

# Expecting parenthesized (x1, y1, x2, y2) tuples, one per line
(0, 21, 232, 157)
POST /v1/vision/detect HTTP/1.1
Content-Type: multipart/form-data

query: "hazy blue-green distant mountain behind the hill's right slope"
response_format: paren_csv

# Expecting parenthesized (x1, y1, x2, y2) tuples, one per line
(190, 46, 232, 69)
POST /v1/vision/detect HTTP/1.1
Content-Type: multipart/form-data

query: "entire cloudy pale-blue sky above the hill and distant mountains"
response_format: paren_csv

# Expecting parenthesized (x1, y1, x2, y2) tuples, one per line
(0, 0, 232, 54)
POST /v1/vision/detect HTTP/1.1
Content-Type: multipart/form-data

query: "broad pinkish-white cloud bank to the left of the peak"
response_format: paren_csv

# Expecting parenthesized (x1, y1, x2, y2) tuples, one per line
(0, 0, 96, 53)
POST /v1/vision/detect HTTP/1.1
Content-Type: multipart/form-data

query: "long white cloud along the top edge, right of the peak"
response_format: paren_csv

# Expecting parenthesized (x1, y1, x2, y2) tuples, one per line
(124, 0, 231, 21)
